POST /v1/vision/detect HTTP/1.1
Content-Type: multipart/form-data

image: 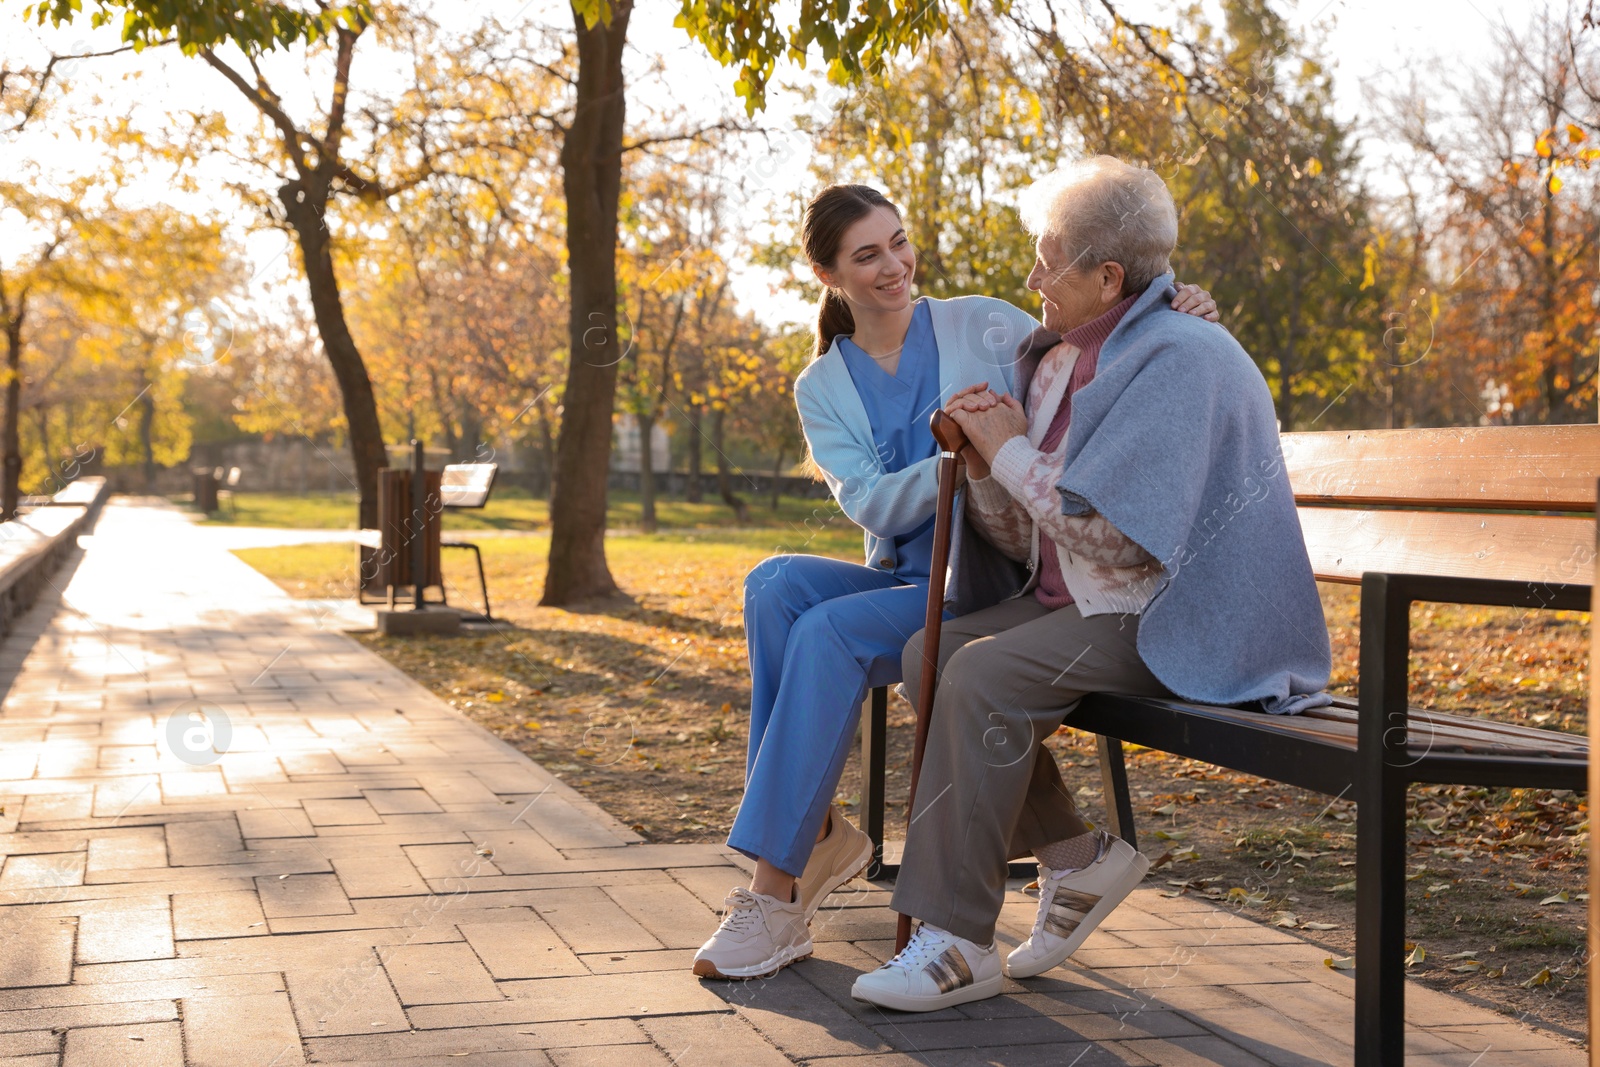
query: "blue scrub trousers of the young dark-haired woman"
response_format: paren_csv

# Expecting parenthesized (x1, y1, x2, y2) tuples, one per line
(728, 555, 928, 877)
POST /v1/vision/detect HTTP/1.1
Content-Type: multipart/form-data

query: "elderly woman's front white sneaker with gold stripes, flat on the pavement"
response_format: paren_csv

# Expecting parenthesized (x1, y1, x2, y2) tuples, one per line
(850, 923, 1000, 1011)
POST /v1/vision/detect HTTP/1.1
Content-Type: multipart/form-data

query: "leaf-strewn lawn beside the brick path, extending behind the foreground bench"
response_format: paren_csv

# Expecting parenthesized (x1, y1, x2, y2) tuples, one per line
(238, 534, 1589, 1035)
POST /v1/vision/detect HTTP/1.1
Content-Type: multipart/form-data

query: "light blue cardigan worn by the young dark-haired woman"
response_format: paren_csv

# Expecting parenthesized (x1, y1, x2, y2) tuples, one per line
(795, 296, 1038, 571)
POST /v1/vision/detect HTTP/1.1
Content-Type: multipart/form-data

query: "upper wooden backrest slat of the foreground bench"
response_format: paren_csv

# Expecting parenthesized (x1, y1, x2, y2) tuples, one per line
(1283, 426, 1600, 512)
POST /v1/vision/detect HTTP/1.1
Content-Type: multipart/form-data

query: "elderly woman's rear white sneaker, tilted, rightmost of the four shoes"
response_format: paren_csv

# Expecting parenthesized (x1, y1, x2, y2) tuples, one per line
(1005, 832, 1150, 977)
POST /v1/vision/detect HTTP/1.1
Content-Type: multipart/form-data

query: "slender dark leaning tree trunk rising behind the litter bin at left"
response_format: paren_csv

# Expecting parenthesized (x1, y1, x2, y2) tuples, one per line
(278, 178, 389, 530)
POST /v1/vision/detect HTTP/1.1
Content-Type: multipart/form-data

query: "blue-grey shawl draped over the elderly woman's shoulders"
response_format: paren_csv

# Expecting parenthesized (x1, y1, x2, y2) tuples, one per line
(1058, 274, 1333, 713)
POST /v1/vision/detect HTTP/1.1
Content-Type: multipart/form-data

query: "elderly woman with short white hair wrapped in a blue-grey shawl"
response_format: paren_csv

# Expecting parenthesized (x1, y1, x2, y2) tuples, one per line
(851, 157, 1331, 1011)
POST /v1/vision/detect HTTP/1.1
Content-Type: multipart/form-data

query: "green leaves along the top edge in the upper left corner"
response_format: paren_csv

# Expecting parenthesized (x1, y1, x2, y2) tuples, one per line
(22, 0, 373, 56)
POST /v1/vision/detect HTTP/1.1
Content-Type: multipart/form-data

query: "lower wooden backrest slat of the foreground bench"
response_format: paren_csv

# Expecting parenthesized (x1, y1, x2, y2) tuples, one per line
(1299, 507, 1595, 584)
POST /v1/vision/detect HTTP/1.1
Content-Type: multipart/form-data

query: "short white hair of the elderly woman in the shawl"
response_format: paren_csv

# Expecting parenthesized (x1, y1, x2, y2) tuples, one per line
(1021, 155, 1178, 294)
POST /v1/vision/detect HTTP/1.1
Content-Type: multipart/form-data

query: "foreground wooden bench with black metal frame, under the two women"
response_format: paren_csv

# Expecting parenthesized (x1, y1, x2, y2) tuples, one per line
(862, 426, 1600, 1067)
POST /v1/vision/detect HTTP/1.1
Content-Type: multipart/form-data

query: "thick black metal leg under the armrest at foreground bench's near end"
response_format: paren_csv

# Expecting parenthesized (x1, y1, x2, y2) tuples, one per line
(1355, 574, 1411, 1067)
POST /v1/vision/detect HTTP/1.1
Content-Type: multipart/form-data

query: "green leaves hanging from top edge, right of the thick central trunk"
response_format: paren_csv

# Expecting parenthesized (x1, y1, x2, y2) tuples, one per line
(672, 0, 985, 115)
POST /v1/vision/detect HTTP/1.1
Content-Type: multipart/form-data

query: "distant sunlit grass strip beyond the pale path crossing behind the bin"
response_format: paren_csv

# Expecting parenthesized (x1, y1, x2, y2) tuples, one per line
(173, 485, 838, 531)
